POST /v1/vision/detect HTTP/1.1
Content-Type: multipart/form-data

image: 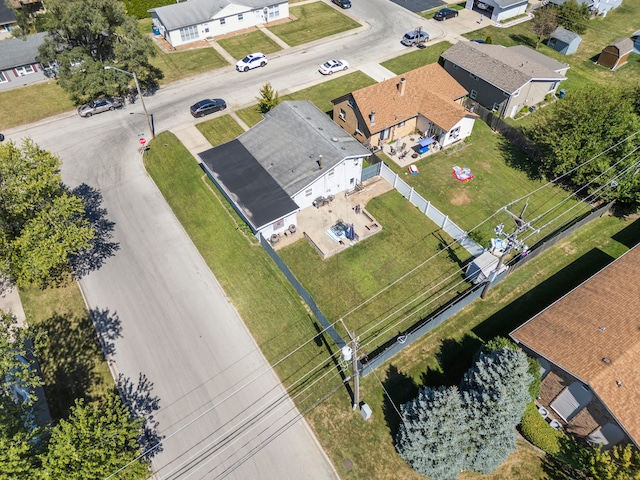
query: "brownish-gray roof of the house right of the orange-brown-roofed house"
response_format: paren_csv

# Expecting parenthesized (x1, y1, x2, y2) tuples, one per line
(442, 42, 568, 94)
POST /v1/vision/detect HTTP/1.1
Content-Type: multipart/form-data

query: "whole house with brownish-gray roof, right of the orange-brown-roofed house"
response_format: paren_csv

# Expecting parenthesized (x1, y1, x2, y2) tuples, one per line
(441, 42, 569, 118)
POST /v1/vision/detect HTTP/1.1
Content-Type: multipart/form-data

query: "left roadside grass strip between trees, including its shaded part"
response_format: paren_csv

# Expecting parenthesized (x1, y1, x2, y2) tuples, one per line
(20, 282, 114, 420)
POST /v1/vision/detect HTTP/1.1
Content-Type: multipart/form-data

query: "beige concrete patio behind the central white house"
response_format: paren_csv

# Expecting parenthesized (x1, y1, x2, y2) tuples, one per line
(272, 178, 393, 258)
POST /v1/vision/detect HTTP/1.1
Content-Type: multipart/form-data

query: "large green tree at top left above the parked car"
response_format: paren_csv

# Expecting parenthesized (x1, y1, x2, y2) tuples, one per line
(40, 0, 162, 103)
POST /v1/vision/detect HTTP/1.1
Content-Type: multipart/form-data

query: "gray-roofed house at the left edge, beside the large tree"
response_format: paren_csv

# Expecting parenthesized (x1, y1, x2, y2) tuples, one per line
(0, 33, 50, 90)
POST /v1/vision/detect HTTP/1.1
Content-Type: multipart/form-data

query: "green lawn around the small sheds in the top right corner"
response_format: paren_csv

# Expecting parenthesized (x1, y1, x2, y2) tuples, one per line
(464, 2, 640, 90)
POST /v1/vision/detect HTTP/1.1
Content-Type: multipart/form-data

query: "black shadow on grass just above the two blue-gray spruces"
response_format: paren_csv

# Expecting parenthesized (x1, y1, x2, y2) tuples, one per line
(420, 335, 482, 388)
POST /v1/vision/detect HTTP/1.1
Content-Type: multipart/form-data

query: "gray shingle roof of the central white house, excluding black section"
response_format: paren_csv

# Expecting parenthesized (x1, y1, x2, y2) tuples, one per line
(238, 101, 371, 196)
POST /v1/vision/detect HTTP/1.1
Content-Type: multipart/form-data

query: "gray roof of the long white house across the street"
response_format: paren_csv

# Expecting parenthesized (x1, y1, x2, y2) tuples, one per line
(149, 0, 282, 30)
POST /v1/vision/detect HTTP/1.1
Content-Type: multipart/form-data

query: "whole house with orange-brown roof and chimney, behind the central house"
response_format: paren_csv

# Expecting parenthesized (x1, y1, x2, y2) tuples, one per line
(332, 63, 477, 147)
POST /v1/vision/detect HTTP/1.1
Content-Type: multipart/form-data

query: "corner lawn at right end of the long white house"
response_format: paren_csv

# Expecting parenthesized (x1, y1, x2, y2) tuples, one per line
(268, 2, 360, 47)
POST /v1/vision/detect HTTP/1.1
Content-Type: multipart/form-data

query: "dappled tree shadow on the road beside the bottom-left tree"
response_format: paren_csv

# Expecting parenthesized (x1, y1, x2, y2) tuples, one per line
(116, 373, 164, 460)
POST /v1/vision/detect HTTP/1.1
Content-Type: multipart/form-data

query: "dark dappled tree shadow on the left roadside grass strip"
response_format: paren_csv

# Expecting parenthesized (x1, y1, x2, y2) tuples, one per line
(34, 313, 104, 420)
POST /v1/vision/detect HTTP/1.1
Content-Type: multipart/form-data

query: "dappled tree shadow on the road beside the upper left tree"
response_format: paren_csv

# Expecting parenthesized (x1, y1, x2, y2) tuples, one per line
(70, 183, 120, 278)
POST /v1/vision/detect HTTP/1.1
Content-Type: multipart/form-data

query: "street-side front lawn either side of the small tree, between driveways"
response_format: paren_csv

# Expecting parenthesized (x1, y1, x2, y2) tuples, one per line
(236, 72, 376, 127)
